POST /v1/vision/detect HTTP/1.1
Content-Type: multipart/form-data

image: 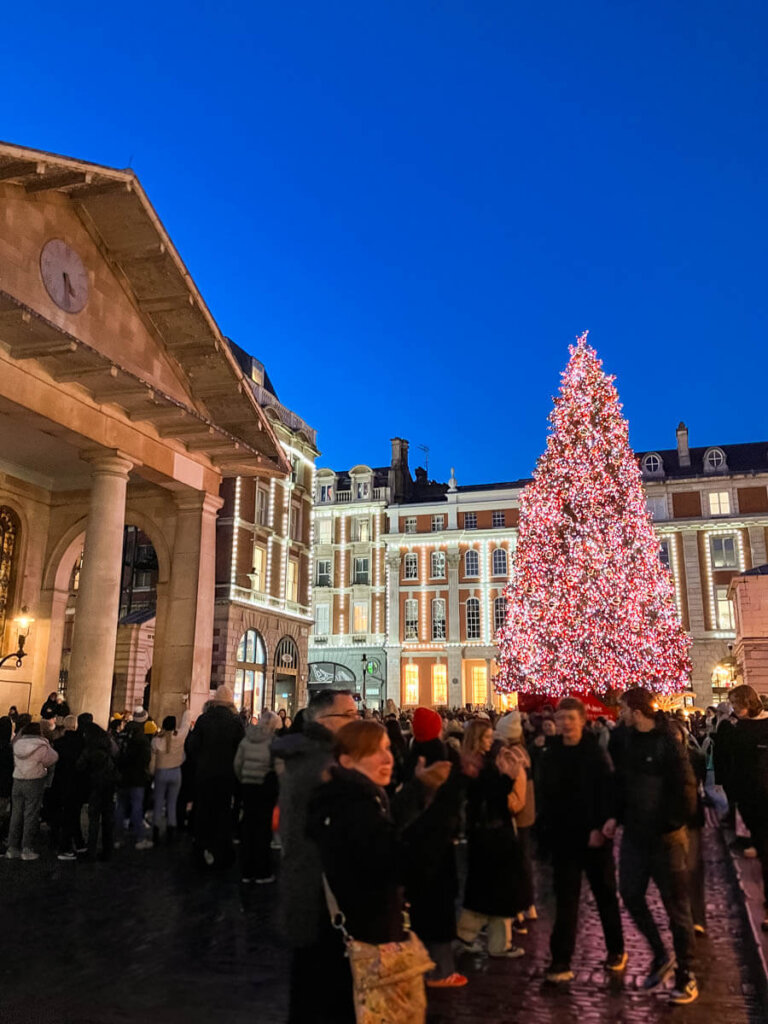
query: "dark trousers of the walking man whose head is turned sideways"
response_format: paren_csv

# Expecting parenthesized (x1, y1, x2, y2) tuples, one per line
(618, 829, 695, 972)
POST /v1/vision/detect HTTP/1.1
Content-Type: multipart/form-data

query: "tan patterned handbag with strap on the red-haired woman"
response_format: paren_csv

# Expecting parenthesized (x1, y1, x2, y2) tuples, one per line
(323, 874, 434, 1024)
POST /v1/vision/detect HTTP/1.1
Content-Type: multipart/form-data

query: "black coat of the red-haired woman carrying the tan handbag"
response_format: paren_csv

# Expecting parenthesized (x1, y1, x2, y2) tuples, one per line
(307, 766, 406, 943)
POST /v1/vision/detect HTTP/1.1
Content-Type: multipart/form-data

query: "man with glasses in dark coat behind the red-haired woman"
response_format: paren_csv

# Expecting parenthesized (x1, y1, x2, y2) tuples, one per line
(272, 689, 359, 1024)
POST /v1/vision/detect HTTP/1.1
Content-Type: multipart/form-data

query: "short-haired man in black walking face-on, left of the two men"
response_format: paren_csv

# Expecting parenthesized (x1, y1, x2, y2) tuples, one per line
(538, 697, 627, 982)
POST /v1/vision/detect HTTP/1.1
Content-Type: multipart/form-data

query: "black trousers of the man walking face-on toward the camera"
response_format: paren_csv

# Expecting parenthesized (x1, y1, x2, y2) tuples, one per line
(550, 843, 624, 968)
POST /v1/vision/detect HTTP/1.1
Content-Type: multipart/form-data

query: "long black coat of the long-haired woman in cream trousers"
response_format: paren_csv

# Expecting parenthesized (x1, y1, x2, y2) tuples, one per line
(464, 758, 525, 918)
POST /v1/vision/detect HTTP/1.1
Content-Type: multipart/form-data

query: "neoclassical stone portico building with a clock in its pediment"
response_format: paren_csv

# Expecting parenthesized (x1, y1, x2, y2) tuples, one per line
(0, 144, 288, 724)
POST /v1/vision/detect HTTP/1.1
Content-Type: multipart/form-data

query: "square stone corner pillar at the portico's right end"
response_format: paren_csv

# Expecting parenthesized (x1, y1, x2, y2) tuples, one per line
(151, 490, 223, 722)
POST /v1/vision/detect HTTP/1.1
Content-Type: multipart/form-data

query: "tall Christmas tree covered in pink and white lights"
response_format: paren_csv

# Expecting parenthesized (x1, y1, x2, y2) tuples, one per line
(496, 334, 690, 697)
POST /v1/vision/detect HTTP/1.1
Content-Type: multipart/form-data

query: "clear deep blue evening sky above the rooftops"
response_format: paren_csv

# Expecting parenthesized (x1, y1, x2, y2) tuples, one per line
(0, 0, 768, 483)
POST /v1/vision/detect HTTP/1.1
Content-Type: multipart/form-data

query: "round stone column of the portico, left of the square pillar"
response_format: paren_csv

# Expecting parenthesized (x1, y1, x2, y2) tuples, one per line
(67, 452, 133, 727)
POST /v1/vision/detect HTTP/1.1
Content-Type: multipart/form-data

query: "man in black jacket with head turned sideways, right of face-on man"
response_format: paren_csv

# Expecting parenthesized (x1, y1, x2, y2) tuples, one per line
(603, 686, 698, 1005)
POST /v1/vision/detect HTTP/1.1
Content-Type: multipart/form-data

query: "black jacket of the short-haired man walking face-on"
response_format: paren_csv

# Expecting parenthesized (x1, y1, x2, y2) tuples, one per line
(537, 732, 616, 852)
